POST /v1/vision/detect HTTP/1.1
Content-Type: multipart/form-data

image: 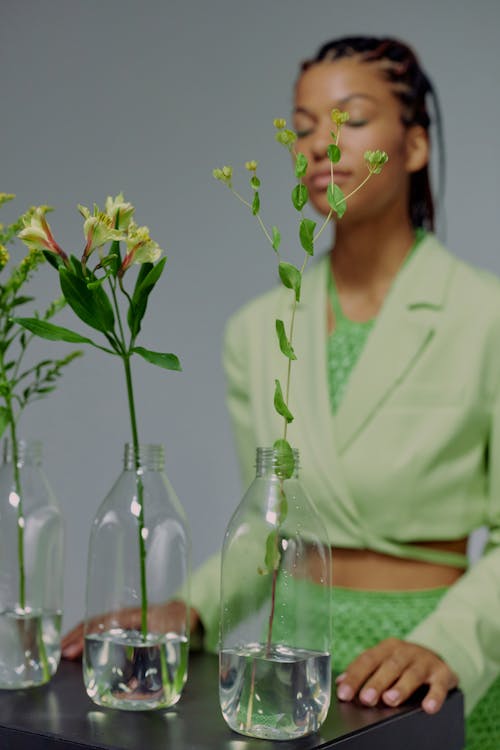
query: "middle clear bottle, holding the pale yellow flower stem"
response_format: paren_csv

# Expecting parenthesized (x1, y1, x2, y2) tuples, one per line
(83, 444, 191, 711)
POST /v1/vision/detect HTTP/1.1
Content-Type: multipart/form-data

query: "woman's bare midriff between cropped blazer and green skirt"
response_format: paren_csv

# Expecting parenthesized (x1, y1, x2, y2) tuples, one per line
(318, 539, 467, 591)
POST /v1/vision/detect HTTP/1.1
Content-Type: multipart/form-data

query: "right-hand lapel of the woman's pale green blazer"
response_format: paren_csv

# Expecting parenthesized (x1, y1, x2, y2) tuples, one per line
(334, 235, 454, 452)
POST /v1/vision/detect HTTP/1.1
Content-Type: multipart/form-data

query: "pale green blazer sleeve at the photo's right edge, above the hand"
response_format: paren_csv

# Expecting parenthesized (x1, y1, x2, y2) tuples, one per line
(406, 384, 500, 714)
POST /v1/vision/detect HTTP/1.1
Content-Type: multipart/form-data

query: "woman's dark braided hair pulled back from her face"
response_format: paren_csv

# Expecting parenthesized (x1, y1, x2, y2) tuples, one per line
(301, 36, 445, 230)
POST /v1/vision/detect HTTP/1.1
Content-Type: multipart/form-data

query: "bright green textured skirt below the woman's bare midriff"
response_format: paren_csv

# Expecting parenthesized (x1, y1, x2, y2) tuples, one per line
(273, 580, 500, 750)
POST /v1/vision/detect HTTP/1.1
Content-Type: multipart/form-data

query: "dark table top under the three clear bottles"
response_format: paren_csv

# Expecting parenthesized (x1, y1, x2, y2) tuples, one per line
(0, 653, 464, 750)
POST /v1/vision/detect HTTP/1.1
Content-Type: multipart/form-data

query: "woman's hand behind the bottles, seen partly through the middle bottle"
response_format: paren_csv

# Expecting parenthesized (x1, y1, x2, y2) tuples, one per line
(61, 601, 202, 660)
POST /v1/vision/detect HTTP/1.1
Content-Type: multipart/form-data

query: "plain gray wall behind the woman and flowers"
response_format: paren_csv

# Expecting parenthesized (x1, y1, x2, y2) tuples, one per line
(0, 0, 500, 627)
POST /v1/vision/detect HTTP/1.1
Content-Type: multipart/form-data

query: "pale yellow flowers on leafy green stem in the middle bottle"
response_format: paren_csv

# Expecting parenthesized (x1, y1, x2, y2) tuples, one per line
(16, 193, 181, 640)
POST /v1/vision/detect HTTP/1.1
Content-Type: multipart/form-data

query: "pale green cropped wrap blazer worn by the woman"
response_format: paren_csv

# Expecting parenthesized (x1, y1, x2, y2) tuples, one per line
(193, 235, 500, 711)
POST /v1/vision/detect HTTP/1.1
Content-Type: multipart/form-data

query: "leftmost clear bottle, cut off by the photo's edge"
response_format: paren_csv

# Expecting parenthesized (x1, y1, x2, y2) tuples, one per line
(0, 440, 64, 689)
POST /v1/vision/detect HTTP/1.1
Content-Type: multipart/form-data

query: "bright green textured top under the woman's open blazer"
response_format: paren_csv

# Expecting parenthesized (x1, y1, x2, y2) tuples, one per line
(326, 228, 426, 414)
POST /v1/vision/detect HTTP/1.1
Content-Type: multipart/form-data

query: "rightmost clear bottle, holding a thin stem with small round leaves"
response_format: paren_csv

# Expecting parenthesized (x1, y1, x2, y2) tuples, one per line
(219, 448, 331, 740)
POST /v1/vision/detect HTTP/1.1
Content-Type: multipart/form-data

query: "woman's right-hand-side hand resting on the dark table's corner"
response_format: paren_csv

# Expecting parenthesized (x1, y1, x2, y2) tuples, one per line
(336, 638, 458, 714)
